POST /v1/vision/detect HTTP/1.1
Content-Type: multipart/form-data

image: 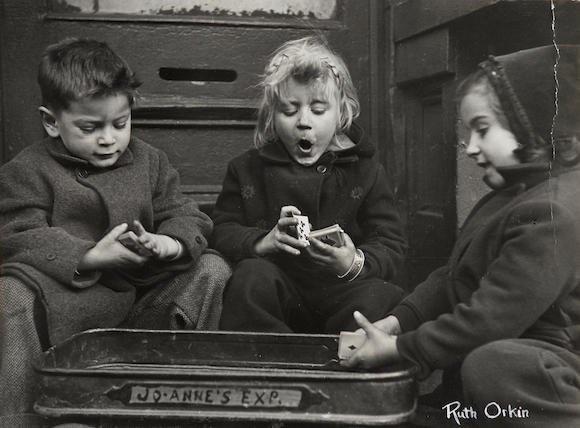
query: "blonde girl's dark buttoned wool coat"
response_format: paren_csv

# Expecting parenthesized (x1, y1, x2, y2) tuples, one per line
(212, 125, 406, 281)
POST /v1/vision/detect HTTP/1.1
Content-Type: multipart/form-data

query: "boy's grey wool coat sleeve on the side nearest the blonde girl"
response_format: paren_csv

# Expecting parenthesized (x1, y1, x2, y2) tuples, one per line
(153, 151, 213, 261)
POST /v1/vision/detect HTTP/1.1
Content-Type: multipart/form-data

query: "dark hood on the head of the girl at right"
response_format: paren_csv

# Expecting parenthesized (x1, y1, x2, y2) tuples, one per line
(480, 45, 580, 163)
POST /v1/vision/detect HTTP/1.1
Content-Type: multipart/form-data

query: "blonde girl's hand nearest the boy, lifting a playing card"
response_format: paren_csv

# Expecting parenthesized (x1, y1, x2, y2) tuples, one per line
(254, 205, 308, 256)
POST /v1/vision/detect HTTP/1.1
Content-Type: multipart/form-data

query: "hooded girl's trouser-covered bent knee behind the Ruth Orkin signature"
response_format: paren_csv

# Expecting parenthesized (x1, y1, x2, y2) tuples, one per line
(461, 339, 580, 428)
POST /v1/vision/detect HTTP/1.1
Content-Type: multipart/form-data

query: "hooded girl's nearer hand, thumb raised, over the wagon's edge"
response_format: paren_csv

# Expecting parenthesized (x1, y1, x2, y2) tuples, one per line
(340, 311, 401, 369)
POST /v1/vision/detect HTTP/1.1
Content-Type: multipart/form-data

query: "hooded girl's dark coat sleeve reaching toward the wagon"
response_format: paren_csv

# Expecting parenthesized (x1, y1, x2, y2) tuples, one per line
(397, 201, 580, 376)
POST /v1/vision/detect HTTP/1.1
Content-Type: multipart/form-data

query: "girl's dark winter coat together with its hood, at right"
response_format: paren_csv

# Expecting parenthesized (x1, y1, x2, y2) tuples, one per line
(393, 45, 580, 374)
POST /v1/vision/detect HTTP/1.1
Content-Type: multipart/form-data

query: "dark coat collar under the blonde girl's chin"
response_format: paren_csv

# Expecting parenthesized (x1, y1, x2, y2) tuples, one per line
(258, 123, 375, 164)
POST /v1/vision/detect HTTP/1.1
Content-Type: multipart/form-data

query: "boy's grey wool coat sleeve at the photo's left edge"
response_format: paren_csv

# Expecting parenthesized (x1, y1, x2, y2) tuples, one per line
(0, 156, 95, 288)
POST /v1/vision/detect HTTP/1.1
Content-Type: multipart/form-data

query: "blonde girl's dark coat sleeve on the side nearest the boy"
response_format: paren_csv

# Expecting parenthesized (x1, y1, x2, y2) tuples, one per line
(212, 162, 268, 262)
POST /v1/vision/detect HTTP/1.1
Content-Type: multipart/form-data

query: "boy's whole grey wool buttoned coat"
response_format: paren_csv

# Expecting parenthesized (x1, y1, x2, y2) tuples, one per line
(0, 138, 212, 342)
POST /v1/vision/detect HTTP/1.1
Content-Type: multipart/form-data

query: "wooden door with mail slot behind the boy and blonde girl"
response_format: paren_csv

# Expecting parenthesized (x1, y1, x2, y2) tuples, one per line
(0, 0, 386, 214)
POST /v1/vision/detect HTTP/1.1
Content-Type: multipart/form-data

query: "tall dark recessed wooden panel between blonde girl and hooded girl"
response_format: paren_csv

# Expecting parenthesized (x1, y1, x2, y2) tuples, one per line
(405, 87, 456, 287)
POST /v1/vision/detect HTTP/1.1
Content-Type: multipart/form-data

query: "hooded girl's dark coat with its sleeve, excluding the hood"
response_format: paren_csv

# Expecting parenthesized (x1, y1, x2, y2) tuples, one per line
(393, 164, 580, 374)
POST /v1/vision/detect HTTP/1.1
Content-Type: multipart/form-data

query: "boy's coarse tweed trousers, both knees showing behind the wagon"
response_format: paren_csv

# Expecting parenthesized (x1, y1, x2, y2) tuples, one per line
(0, 253, 231, 428)
